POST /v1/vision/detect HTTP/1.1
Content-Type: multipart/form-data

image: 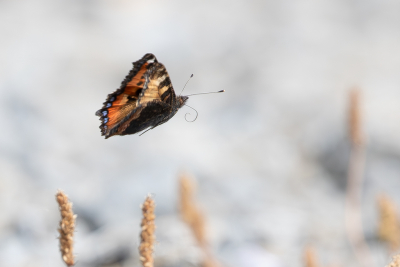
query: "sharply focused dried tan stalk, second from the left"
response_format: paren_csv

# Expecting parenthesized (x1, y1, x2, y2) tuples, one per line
(139, 196, 156, 267)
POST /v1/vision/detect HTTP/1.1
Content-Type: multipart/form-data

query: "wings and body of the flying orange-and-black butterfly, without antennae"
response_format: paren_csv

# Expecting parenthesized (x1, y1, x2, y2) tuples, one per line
(96, 54, 188, 138)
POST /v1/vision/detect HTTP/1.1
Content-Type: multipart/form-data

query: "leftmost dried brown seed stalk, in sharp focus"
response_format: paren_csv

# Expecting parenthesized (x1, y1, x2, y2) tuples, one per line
(56, 190, 76, 266)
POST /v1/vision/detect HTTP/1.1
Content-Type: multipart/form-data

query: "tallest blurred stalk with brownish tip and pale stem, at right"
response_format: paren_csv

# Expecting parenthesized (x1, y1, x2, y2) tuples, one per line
(345, 89, 374, 267)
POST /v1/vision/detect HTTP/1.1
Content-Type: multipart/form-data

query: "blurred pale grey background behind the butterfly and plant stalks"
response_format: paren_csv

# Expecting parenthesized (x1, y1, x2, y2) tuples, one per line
(0, 0, 400, 267)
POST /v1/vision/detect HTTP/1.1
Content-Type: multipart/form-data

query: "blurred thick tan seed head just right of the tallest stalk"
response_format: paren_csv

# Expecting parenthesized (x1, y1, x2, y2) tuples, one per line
(378, 195, 400, 251)
